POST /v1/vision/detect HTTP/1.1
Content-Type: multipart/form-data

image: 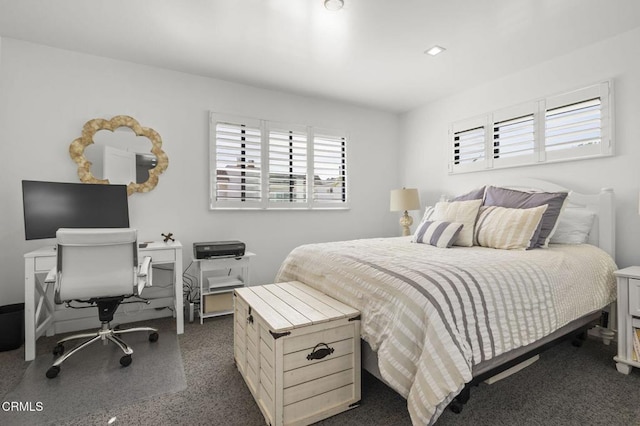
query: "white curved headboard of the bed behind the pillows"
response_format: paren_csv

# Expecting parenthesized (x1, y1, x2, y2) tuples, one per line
(493, 178, 616, 260)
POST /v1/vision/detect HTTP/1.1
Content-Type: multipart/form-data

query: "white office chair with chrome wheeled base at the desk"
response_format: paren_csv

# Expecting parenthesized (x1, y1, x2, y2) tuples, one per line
(47, 228, 158, 379)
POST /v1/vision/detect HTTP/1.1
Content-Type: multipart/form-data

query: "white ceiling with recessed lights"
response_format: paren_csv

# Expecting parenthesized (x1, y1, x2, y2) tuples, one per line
(0, 0, 640, 112)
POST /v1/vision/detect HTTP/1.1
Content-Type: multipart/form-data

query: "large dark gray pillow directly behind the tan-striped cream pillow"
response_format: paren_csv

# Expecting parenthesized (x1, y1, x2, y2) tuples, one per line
(484, 186, 568, 248)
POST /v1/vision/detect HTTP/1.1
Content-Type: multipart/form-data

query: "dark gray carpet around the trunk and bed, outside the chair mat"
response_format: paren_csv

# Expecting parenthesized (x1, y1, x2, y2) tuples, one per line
(0, 316, 640, 426)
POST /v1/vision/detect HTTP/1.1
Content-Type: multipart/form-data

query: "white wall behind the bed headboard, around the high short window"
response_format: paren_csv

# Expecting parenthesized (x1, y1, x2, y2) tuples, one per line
(400, 29, 640, 267)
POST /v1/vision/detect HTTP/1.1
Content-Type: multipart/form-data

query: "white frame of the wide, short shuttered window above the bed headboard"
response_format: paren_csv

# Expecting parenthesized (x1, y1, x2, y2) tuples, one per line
(448, 80, 614, 174)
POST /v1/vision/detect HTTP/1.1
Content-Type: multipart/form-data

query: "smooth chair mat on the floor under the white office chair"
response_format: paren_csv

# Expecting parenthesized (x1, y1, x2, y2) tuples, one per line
(1, 320, 187, 425)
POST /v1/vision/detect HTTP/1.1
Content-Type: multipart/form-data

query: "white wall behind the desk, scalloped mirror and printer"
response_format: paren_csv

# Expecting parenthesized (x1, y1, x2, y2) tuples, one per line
(0, 38, 399, 305)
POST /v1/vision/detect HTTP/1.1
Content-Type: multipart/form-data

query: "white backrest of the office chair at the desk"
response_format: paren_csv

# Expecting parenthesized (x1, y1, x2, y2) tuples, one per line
(55, 228, 138, 303)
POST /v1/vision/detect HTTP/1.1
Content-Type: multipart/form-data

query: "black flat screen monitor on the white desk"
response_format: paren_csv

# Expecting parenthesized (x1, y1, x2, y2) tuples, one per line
(22, 180, 129, 240)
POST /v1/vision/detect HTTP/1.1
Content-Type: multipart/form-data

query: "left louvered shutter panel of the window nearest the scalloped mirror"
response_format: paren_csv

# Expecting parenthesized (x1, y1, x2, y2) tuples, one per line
(212, 119, 262, 207)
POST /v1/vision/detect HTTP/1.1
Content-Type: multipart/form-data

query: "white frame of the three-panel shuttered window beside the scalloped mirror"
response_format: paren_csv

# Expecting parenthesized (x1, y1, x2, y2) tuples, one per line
(209, 111, 350, 210)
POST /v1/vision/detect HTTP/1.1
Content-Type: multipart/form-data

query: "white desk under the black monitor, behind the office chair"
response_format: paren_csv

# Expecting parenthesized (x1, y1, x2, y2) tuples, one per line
(24, 241, 184, 361)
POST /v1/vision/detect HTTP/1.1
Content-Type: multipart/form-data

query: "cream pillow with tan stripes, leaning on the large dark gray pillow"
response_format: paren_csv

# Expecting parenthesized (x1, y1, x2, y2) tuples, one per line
(475, 204, 547, 250)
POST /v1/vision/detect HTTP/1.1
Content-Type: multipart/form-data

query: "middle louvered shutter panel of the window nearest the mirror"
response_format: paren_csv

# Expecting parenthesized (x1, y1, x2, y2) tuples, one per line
(268, 128, 307, 204)
